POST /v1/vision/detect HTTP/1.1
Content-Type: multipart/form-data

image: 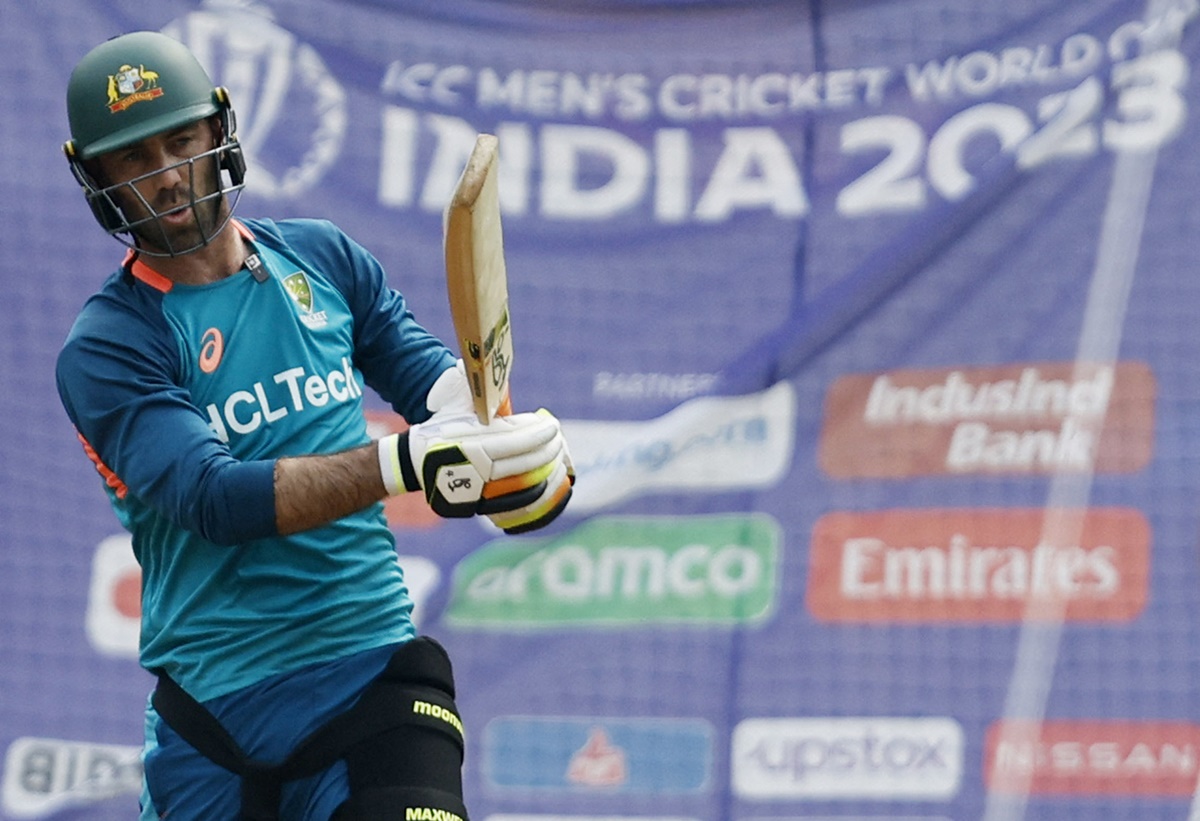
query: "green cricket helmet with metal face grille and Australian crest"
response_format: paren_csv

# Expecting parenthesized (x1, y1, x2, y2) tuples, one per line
(62, 31, 246, 256)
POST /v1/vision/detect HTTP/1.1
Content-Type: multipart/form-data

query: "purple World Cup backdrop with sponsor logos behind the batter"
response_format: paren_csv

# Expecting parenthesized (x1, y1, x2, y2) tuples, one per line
(0, 0, 1200, 821)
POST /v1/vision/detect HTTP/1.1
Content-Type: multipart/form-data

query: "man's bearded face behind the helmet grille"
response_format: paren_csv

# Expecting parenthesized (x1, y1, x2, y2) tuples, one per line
(96, 120, 226, 252)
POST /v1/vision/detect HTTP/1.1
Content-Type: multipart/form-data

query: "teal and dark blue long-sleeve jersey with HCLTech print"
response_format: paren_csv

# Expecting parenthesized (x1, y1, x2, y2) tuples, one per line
(56, 220, 455, 701)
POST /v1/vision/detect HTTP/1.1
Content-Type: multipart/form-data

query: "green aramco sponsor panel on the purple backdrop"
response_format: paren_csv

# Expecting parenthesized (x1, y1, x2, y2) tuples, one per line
(445, 514, 780, 628)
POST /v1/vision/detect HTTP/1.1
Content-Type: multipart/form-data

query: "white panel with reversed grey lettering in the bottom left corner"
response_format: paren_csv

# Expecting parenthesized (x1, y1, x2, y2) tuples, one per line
(2, 737, 142, 819)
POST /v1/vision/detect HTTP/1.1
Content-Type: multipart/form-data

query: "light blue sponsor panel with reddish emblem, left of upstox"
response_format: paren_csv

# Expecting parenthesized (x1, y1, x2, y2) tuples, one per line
(482, 717, 714, 795)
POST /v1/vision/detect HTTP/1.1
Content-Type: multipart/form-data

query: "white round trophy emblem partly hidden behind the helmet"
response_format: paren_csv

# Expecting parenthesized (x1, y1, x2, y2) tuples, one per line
(162, 0, 347, 200)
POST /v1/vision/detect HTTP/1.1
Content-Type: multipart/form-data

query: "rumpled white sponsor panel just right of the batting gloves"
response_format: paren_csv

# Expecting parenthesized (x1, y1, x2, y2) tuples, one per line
(563, 382, 796, 513)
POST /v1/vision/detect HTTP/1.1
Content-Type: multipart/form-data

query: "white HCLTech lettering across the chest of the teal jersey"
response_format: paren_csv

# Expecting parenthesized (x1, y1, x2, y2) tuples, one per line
(205, 356, 362, 442)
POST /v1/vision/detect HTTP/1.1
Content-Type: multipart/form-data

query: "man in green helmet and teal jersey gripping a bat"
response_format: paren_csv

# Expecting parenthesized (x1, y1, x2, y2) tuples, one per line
(56, 31, 574, 821)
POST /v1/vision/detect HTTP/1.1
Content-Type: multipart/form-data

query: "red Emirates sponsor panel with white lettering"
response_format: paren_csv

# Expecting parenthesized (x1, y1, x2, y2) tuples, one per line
(805, 508, 1151, 622)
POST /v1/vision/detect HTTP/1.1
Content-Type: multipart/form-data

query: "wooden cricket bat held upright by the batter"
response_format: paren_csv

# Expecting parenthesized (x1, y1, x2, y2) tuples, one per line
(443, 134, 512, 425)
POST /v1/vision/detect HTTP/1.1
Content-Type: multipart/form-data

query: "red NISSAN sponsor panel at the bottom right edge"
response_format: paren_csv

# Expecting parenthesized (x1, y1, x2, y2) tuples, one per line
(984, 720, 1200, 796)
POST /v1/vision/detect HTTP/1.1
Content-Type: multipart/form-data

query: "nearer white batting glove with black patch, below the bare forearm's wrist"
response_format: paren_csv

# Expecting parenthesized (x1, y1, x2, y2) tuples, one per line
(379, 408, 566, 519)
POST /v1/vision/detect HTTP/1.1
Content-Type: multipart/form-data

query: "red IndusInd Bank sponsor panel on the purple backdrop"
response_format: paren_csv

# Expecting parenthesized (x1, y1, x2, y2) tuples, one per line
(820, 362, 1156, 479)
